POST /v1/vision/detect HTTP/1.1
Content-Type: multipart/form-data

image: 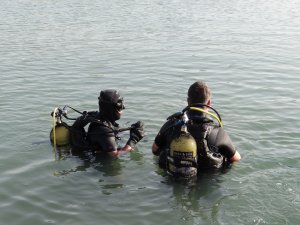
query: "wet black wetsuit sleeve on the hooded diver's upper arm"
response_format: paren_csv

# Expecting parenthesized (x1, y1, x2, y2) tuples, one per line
(88, 124, 118, 152)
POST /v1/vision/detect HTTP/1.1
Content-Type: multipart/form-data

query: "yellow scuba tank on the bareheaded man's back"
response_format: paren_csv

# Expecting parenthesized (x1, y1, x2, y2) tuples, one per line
(167, 118, 197, 178)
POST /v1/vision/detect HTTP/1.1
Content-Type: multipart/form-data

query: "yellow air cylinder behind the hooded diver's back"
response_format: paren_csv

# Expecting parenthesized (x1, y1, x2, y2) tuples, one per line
(50, 124, 70, 146)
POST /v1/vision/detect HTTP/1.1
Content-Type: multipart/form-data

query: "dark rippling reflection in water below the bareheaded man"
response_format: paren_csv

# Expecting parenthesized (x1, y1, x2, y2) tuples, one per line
(163, 169, 229, 224)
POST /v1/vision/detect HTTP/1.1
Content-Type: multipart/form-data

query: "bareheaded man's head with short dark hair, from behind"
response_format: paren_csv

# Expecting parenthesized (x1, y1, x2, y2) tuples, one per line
(188, 81, 211, 105)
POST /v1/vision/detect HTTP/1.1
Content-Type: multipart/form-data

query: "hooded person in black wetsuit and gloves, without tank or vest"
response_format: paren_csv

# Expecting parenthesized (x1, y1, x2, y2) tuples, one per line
(87, 89, 144, 157)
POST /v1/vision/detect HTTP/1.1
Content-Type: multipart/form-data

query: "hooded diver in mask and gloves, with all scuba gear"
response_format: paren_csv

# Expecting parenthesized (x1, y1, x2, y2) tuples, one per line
(50, 89, 144, 157)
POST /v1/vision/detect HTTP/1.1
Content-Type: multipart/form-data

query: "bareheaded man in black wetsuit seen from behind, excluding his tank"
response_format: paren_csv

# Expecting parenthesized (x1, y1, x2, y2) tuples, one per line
(152, 81, 241, 176)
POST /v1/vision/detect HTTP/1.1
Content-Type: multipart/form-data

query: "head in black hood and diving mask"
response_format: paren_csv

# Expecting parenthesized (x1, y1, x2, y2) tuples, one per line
(98, 89, 125, 123)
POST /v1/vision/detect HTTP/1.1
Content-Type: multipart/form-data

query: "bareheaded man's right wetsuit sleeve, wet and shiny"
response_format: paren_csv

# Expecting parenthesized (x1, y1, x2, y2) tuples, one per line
(208, 127, 236, 159)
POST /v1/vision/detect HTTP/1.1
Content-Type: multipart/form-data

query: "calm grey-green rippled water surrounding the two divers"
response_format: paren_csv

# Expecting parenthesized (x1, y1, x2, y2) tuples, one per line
(0, 0, 300, 225)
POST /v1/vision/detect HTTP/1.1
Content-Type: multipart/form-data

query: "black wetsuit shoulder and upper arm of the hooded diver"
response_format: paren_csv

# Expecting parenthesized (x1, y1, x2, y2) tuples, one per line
(87, 118, 119, 153)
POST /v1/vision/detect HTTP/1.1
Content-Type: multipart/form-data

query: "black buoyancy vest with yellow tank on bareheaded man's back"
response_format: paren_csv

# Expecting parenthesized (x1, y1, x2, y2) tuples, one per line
(167, 105, 225, 178)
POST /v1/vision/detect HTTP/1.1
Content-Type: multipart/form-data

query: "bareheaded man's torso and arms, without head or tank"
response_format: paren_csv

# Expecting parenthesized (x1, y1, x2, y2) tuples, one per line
(153, 111, 237, 170)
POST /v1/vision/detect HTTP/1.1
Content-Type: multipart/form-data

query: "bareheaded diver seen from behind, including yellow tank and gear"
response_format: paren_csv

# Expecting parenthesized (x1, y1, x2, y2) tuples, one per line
(152, 81, 241, 178)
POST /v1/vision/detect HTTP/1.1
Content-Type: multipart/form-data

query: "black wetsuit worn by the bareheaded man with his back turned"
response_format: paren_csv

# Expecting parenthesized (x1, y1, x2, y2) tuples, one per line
(155, 111, 236, 170)
